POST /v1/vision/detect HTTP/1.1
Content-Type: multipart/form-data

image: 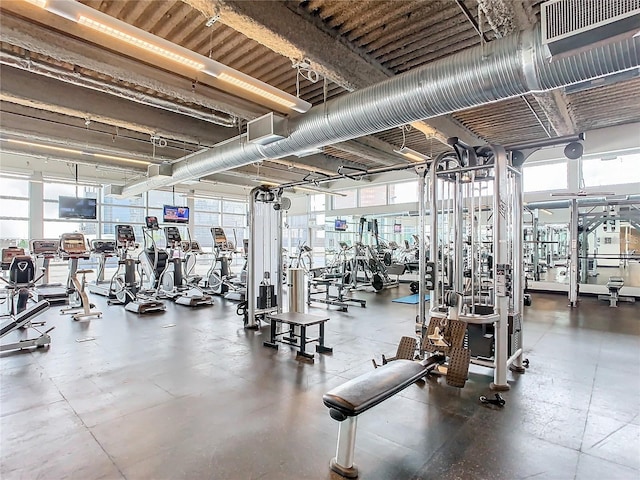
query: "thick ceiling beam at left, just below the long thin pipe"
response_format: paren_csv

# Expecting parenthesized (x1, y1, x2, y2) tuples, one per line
(0, 65, 236, 146)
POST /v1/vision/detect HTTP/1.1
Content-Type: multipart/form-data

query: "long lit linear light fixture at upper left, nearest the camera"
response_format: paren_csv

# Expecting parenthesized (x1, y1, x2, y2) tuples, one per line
(25, 0, 311, 113)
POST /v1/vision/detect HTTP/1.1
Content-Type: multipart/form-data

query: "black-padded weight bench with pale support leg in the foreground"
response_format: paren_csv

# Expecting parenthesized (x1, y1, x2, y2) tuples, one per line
(322, 355, 446, 478)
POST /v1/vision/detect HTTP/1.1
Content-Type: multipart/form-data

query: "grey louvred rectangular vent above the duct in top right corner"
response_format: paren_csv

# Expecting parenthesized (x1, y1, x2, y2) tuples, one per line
(540, 0, 640, 56)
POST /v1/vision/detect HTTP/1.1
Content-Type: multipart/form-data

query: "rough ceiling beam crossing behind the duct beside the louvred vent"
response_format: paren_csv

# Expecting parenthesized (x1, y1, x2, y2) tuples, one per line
(478, 0, 578, 136)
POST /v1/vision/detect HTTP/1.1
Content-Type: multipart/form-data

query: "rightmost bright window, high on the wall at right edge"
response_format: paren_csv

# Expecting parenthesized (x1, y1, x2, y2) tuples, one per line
(582, 154, 640, 187)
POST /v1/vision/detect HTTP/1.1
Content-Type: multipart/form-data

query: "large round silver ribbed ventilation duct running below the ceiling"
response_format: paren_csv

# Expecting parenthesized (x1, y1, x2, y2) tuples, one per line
(124, 30, 640, 195)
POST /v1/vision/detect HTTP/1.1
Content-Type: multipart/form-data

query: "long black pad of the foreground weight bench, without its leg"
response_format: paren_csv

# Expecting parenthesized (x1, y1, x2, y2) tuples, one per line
(322, 355, 443, 418)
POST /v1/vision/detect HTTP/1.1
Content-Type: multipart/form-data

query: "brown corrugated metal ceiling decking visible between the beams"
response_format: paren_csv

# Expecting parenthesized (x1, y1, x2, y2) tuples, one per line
(1, 0, 640, 186)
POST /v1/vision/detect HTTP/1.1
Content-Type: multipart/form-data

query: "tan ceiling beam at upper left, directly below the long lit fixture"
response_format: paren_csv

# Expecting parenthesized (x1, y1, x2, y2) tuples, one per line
(0, 8, 269, 119)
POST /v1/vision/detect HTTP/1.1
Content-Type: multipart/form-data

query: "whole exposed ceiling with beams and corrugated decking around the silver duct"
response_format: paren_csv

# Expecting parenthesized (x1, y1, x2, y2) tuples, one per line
(0, 0, 640, 193)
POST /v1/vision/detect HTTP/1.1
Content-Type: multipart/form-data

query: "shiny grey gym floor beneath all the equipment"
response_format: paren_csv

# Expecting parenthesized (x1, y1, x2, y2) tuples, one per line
(0, 286, 640, 480)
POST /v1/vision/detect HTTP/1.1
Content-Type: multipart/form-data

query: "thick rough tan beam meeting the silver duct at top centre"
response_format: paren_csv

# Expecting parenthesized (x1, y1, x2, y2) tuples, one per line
(183, 0, 478, 143)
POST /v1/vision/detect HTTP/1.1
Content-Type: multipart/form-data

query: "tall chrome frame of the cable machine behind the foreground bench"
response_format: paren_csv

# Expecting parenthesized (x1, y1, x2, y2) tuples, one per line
(417, 142, 524, 390)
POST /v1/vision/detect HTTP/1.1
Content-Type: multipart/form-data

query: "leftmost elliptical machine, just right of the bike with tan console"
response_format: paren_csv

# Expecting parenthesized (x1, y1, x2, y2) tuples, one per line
(109, 225, 167, 314)
